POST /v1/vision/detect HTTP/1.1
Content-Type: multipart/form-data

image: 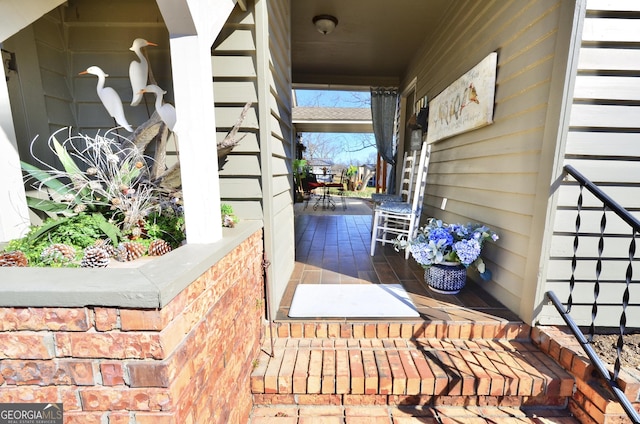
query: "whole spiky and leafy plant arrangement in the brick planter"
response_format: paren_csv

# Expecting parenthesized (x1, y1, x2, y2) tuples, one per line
(5, 129, 185, 266)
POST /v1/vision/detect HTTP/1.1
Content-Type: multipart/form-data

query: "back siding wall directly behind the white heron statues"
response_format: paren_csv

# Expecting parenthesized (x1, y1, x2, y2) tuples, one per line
(63, 0, 170, 135)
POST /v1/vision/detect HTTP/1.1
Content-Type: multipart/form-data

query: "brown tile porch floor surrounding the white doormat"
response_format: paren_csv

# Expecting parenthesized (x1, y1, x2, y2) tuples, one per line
(275, 210, 520, 322)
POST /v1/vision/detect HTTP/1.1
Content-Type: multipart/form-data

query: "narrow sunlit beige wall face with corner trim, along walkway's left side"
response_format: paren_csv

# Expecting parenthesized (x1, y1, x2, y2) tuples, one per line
(257, 0, 295, 314)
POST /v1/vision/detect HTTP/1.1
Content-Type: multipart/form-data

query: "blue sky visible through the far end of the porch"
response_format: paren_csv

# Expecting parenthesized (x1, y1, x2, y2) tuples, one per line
(296, 89, 376, 165)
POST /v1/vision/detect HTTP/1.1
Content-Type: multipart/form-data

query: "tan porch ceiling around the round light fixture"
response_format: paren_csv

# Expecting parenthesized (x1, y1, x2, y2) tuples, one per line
(291, 0, 455, 88)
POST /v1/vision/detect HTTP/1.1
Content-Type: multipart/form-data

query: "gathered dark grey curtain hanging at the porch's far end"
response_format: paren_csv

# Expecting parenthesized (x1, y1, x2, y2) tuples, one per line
(371, 87, 398, 194)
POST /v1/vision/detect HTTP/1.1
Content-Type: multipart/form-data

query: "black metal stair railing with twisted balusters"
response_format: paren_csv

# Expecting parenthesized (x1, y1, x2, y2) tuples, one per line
(546, 165, 640, 423)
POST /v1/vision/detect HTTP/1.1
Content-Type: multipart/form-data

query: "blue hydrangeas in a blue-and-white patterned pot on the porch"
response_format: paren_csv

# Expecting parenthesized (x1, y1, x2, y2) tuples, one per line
(395, 218, 498, 294)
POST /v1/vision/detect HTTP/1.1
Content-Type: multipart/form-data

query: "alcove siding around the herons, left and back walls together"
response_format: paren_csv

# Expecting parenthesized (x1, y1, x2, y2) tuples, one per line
(7, 0, 173, 167)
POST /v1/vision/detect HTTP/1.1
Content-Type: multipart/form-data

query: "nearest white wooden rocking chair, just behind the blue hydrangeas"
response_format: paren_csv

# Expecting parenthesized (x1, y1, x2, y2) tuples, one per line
(371, 142, 431, 259)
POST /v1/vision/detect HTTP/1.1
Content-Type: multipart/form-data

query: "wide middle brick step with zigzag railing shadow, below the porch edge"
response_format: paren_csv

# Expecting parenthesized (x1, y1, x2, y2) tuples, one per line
(251, 337, 574, 407)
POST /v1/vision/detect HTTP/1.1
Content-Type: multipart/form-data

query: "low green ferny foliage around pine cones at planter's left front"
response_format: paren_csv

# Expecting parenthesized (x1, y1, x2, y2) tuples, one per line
(5, 213, 122, 267)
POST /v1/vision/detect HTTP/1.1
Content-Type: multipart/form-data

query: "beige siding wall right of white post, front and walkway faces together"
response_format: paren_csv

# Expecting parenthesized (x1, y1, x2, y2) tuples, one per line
(212, 0, 295, 311)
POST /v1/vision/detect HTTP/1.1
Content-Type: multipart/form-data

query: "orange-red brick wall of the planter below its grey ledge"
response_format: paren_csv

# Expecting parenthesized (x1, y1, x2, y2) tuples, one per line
(0, 231, 264, 424)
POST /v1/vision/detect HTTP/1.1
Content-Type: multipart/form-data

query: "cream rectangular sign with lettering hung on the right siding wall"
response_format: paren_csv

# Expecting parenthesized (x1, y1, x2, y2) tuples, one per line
(427, 52, 498, 142)
